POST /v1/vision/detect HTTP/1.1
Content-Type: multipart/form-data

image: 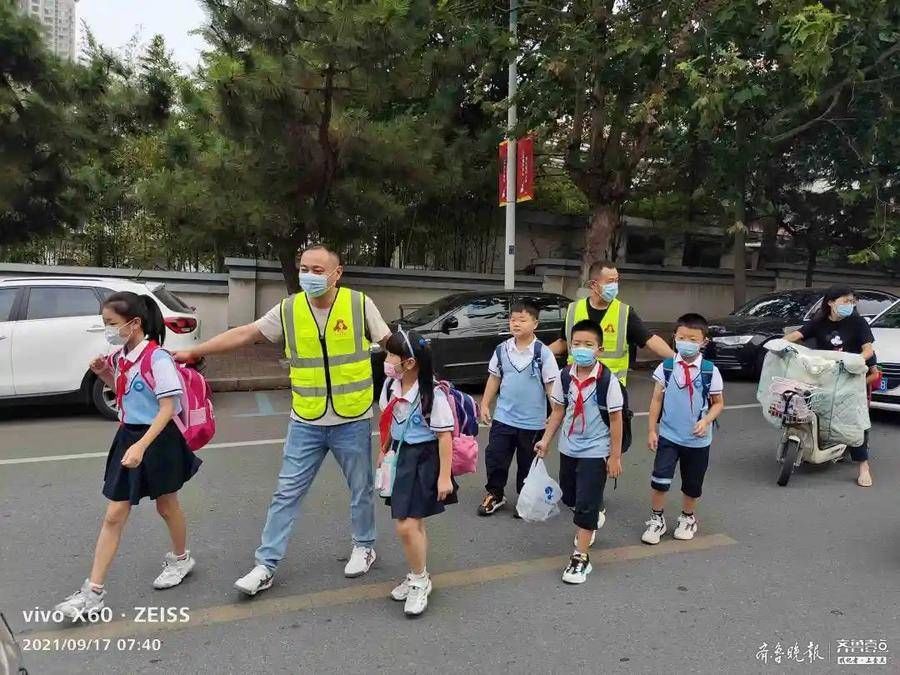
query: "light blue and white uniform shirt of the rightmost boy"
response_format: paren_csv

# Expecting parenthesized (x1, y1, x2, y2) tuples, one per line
(653, 354, 724, 448)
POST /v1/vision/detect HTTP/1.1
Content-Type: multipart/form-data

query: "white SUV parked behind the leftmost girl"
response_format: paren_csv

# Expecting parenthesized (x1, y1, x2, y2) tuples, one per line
(0, 277, 200, 419)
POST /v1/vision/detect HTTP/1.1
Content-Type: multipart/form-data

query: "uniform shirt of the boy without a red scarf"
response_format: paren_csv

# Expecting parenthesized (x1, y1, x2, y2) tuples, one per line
(488, 337, 559, 431)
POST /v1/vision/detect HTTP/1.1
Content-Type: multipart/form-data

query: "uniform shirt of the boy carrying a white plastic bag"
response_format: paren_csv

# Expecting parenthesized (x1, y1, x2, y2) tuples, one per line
(550, 363, 624, 459)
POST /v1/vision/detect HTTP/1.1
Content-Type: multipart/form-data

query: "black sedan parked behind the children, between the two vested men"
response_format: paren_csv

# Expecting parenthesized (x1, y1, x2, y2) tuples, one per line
(372, 291, 570, 396)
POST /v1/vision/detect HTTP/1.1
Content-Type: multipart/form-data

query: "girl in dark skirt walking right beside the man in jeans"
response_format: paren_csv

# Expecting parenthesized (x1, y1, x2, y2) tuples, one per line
(378, 329, 457, 616)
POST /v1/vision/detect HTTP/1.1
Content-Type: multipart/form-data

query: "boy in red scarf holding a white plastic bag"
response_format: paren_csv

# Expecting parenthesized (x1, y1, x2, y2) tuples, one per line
(534, 320, 623, 584)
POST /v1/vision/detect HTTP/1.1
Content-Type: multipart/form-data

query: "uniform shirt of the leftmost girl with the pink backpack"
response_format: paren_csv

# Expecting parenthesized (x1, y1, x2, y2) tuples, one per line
(110, 340, 182, 425)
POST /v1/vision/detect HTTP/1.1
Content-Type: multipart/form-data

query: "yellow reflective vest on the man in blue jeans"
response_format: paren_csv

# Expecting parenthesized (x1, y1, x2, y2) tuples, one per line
(281, 288, 372, 421)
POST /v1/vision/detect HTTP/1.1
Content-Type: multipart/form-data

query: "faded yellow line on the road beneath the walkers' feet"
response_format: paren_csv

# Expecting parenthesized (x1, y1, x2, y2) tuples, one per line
(19, 534, 737, 640)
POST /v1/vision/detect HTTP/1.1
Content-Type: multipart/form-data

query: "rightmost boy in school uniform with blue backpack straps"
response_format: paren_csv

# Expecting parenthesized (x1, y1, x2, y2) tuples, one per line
(641, 314, 725, 544)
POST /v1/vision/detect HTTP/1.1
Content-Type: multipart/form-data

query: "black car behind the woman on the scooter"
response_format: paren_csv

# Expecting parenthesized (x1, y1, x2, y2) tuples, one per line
(707, 288, 897, 377)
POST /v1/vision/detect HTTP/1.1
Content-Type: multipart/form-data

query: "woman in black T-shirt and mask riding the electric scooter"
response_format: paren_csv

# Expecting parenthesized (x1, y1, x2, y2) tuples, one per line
(784, 286, 877, 487)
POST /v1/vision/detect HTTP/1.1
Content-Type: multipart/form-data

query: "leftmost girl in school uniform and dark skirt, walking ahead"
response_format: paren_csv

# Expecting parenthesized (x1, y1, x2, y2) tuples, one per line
(56, 292, 200, 619)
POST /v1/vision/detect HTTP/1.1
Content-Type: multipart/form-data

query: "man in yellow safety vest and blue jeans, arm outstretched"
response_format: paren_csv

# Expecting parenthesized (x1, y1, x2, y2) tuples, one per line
(175, 246, 390, 596)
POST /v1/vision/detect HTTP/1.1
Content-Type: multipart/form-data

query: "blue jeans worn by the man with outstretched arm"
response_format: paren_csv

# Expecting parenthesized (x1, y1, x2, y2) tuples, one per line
(256, 420, 375, 571)
